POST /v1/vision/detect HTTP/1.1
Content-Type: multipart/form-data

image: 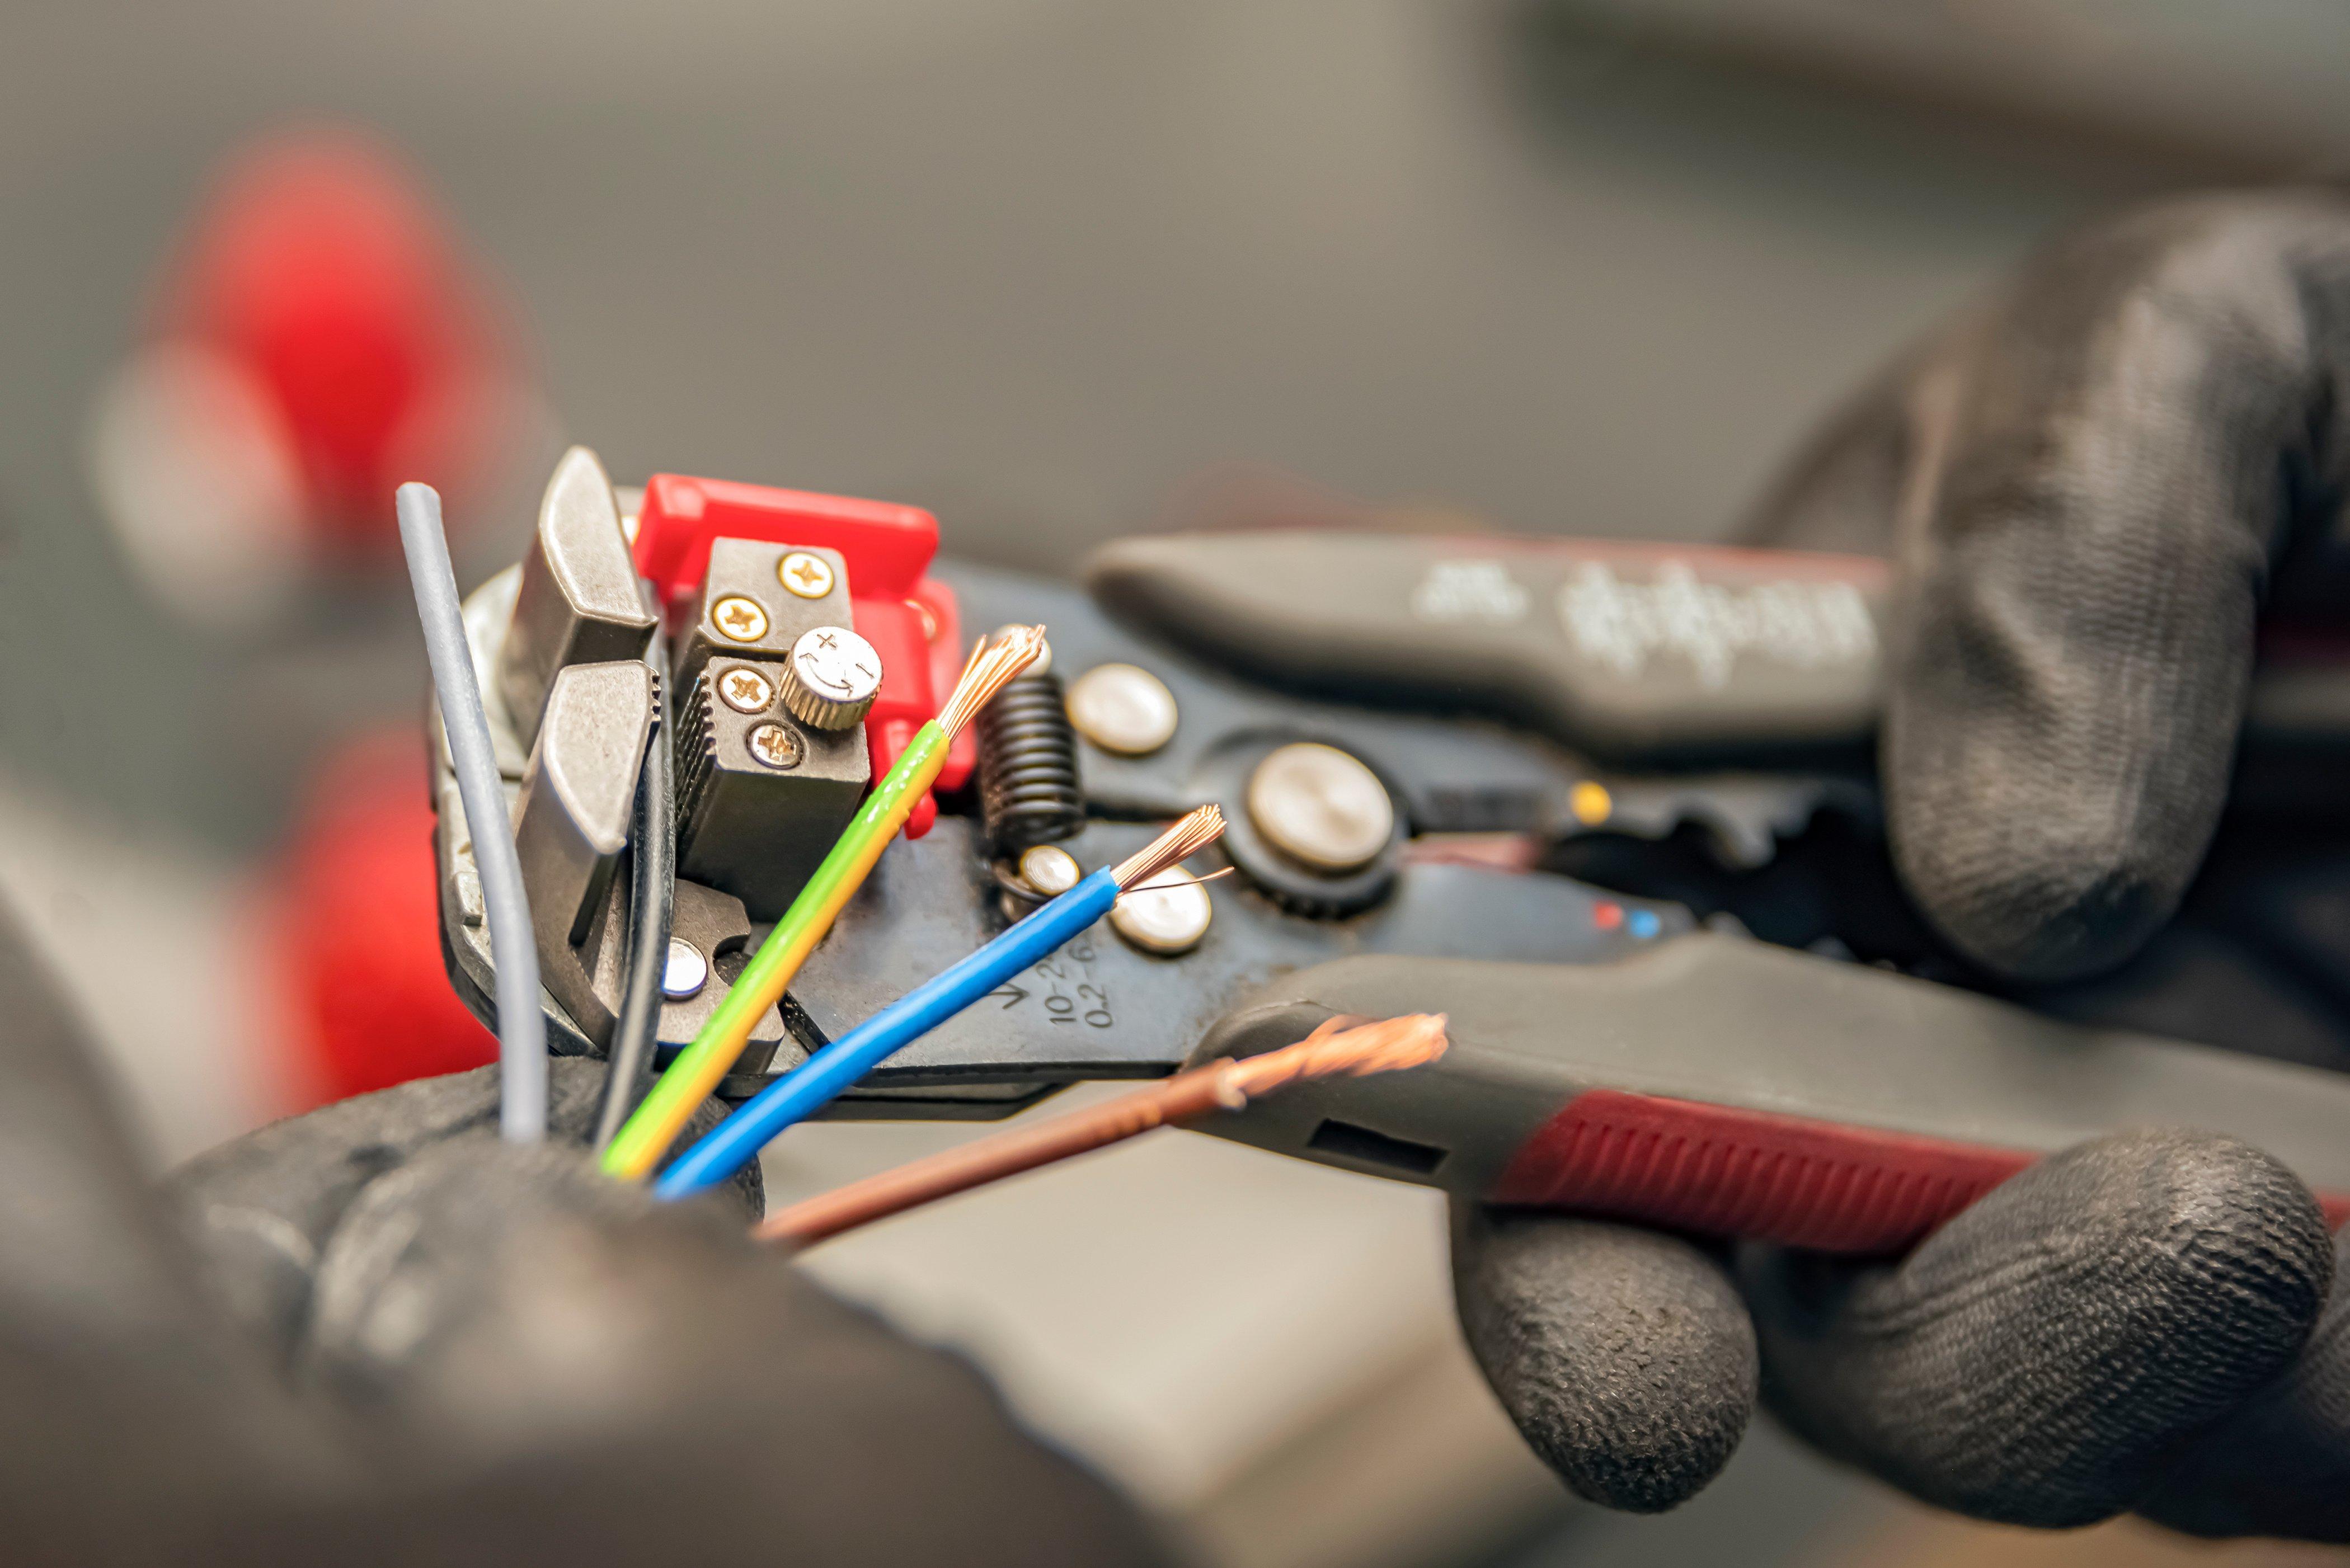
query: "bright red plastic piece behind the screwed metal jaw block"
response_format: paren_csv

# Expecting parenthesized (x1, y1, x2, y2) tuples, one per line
(637, 473, 977, 839)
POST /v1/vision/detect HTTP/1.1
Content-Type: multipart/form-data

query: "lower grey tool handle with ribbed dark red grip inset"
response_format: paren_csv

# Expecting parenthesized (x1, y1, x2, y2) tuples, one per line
(1198, 933, 2350, 1253)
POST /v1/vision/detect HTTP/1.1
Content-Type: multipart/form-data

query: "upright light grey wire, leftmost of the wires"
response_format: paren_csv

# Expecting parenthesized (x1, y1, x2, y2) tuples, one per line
(397, 484, 548, 1142)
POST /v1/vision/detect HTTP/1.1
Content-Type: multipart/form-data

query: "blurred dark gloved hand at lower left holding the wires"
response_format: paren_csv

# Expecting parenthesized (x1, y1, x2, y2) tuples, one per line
(0, 907, 1161, 1568)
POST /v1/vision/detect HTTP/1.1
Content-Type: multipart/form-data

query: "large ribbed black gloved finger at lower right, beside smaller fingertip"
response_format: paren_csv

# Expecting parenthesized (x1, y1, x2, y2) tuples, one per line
(1741, 1131, 2350, 1537)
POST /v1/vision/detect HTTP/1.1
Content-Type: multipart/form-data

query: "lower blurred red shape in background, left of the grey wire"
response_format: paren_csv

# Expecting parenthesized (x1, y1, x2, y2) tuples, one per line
(272, 727, 498, 1110)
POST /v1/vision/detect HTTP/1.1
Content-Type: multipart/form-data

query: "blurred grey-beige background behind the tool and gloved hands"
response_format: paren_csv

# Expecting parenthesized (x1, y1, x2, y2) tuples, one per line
(0, 0, 2350, 1568)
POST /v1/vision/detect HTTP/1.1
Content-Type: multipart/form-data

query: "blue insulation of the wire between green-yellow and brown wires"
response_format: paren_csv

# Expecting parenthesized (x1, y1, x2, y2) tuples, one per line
(654, 865, 1118, 1199)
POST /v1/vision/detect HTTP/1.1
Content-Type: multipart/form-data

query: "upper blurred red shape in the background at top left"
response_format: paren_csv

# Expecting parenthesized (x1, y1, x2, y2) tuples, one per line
(157, 129, 510, 548)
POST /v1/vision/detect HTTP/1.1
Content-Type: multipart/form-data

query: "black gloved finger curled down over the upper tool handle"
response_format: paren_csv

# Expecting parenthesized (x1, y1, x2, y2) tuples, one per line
(1746, 193, 2350, 980)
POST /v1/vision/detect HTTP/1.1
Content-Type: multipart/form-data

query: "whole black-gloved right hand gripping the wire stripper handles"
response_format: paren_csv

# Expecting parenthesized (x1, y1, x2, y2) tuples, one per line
(1457, 193, 2350, 1540)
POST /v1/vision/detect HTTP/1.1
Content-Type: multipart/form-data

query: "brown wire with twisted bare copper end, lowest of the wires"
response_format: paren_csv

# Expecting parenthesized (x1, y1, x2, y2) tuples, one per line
(752, 1013, 1445, 1246)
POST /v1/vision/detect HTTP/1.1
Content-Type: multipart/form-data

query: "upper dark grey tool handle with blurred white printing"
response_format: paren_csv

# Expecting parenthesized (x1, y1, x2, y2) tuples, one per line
(1088, 529, 2350, 762)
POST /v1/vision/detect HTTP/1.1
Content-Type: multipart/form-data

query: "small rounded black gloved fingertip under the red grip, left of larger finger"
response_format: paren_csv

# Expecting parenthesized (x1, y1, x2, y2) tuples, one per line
(1453, 1213, 1755, 1514)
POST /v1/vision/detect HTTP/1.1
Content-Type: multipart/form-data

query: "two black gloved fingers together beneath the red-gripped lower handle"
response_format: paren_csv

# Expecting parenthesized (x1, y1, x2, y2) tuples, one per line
(1455, 1131, 2350, 1540)
